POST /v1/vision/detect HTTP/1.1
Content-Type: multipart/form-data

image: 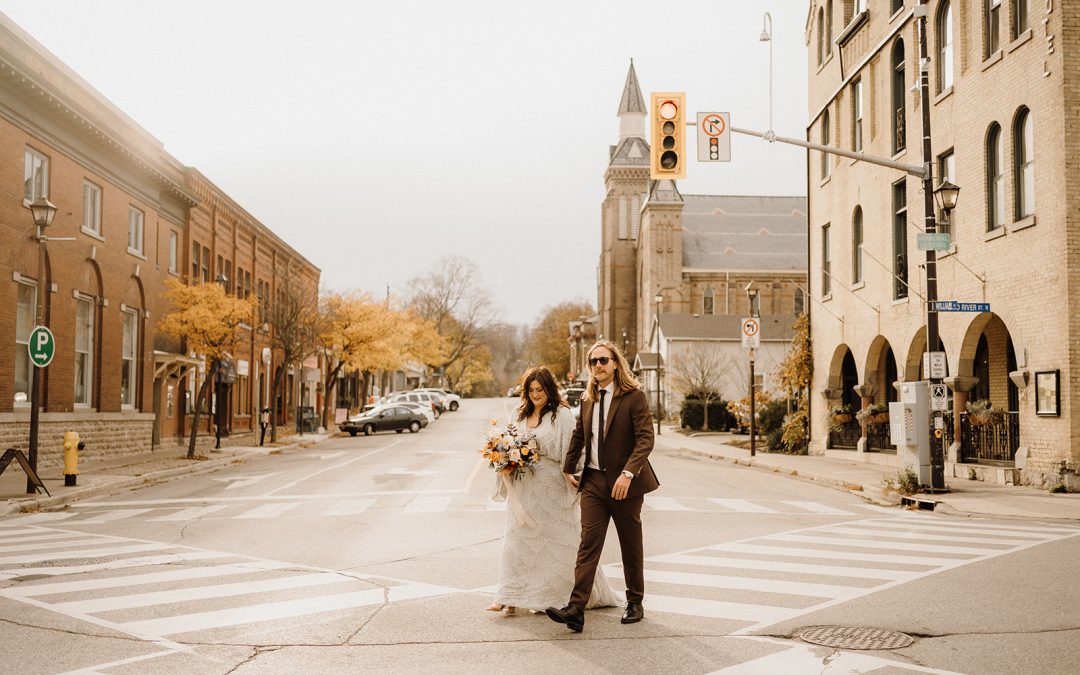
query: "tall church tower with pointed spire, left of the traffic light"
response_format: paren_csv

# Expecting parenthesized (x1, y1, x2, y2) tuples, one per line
(597, 60, 649, 362)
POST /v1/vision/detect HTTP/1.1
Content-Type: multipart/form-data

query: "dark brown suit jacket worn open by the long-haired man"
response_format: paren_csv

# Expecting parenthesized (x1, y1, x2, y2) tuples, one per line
(563, 382, 660, 497)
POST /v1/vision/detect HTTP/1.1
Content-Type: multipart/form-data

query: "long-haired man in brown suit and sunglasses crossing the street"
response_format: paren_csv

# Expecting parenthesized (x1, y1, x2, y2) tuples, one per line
(546, 340, 660, 633)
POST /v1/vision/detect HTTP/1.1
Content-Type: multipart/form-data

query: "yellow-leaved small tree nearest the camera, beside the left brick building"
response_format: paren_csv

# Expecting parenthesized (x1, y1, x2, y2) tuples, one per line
(158, 279, 255, 459)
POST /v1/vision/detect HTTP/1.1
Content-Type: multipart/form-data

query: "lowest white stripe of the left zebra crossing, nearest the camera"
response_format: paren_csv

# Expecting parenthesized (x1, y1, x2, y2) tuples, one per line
(118, 584, 457, 635)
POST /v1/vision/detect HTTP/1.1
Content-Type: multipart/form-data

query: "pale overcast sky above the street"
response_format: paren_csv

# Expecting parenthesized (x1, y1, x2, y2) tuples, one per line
(2, 0, 807, 324)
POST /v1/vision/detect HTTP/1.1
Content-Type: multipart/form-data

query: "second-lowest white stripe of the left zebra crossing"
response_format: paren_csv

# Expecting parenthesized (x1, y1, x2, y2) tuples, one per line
(52, 572, 356, 615)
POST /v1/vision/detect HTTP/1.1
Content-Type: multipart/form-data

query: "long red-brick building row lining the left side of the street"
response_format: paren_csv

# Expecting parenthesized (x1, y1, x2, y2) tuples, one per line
(0, 15, 319, 465)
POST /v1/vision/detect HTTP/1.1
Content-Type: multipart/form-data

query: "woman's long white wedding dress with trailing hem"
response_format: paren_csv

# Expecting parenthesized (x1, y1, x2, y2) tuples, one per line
(495, 406, 622, 610)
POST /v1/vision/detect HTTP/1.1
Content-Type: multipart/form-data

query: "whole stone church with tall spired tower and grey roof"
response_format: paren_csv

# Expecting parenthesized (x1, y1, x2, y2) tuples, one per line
(596, 64, 807, 408)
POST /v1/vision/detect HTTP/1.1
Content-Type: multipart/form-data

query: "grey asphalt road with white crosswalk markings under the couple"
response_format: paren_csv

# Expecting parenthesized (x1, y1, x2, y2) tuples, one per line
(0, 399, 1080, 674)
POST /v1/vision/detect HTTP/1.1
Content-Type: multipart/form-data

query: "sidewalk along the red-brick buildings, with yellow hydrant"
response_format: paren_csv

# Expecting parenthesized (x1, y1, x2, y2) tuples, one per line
(0, 433, 330, 516)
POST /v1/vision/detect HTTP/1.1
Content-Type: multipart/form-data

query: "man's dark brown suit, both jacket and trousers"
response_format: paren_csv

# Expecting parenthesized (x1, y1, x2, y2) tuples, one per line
(563, 389, 660, 610)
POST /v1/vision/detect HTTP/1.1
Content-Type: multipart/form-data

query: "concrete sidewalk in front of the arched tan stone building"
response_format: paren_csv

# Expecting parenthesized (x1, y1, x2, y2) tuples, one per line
(657, 427, 1080, 522)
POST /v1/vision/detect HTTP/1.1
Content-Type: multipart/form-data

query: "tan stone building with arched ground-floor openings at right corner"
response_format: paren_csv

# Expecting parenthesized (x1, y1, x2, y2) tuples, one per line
(806, 0, 1080, 488)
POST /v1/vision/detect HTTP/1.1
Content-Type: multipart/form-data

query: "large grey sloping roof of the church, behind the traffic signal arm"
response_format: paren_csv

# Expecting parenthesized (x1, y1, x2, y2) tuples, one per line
(678, 194, 809, 272)
